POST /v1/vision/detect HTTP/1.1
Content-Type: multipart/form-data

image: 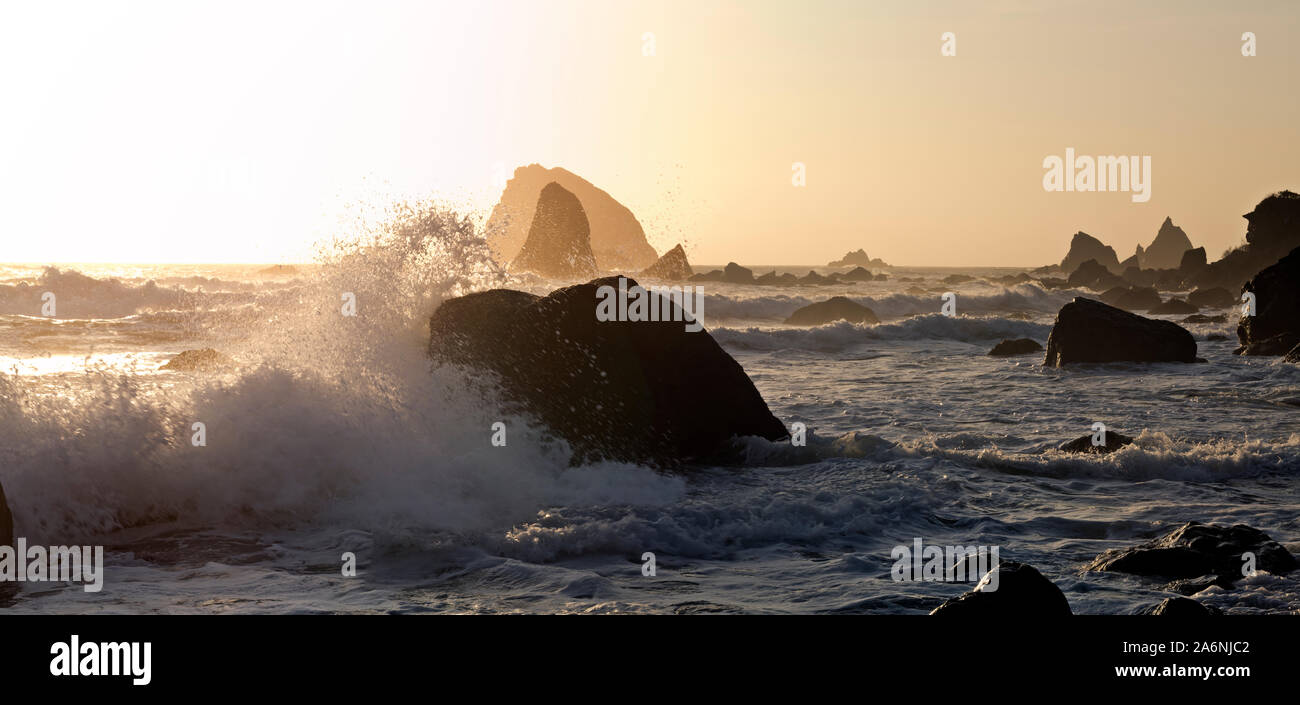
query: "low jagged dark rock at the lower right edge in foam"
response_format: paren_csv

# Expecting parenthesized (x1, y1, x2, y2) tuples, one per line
(1087, 522, 1297, 583)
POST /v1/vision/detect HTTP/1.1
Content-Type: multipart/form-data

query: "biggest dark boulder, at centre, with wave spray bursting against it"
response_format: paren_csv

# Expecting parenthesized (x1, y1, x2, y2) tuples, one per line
(429, 277, 788, 466)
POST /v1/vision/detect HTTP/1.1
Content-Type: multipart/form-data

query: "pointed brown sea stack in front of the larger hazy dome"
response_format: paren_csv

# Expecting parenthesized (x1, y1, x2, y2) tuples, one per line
(510, 182, 595, 278)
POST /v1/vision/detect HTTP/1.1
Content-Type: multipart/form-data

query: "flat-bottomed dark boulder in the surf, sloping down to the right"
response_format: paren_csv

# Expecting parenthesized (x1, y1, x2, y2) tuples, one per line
(1043, 297, 1196, 367)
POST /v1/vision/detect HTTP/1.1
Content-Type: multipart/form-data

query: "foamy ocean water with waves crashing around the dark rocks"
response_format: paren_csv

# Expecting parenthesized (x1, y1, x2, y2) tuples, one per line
(0, 220, 1300, 614)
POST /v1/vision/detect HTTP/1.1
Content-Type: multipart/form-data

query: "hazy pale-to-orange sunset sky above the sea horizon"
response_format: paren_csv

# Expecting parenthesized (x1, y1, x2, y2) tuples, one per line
(0, 0, 1300, 265)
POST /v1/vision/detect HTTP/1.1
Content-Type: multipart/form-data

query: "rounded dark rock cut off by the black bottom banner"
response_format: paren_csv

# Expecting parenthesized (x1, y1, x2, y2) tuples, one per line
(930, 561, 1073, 618)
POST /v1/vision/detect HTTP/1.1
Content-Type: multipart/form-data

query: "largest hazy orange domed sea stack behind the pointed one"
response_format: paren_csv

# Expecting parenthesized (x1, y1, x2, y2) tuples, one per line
(485, 164, 659, 272)
